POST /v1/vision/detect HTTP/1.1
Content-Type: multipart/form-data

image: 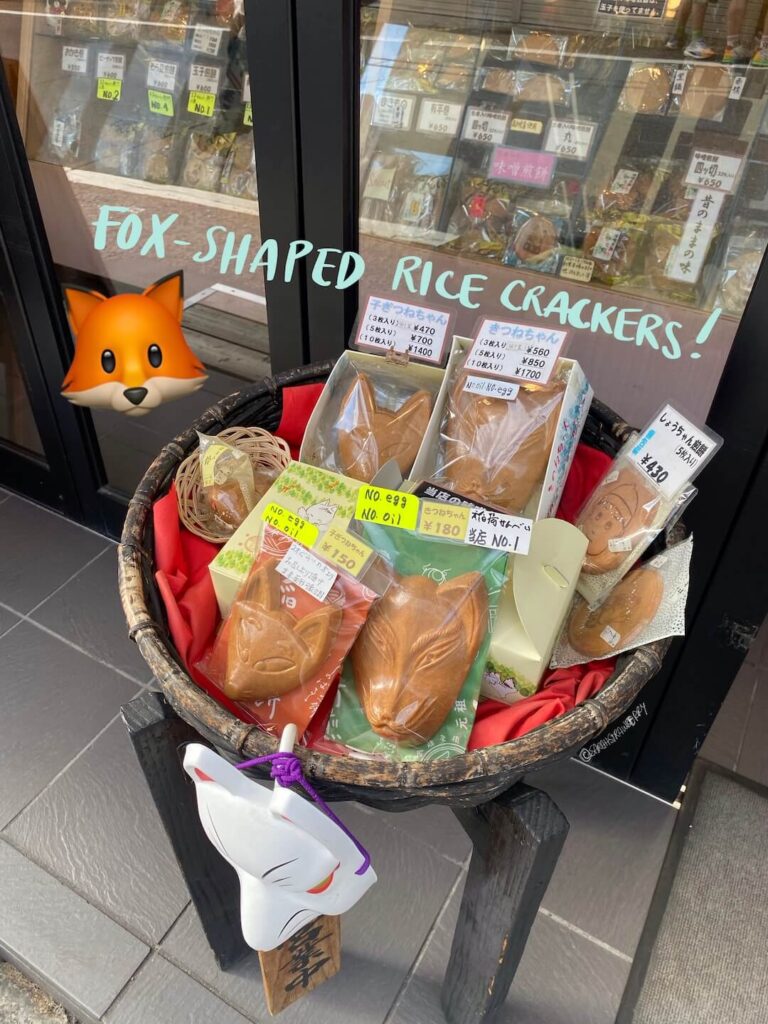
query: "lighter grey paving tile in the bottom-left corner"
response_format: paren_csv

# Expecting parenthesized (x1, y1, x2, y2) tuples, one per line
(0, 840, 149, 1022)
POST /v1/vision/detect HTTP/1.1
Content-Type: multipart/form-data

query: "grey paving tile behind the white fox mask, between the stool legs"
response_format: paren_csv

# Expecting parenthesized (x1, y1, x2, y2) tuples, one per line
(161, 804, 459, 1024)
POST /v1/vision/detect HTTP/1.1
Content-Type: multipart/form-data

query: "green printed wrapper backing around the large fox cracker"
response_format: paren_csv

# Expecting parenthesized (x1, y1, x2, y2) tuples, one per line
(326, 523, 507, 761)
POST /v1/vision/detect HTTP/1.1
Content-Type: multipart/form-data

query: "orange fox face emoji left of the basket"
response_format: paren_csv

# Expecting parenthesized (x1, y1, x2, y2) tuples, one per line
(61, 270, 207, 416)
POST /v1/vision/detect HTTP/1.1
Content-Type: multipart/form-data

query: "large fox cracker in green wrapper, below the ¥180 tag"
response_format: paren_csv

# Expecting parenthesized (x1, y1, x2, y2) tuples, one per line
(326, 523, 507, 761)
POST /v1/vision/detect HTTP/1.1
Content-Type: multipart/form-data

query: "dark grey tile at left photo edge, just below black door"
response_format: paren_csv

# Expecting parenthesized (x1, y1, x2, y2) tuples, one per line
(0, 497, 106, 612)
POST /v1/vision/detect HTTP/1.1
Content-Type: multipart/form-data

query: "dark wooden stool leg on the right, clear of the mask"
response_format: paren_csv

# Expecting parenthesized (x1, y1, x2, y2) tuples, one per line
(442, 785, 568, 1024)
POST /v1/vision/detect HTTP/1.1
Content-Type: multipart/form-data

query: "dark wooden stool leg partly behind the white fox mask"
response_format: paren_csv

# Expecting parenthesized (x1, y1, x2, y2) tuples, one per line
(122, 691, 251, 971)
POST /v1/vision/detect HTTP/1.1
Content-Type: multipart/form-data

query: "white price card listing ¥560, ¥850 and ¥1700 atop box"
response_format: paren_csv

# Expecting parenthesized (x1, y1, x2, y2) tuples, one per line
(464, 319, 567, 384)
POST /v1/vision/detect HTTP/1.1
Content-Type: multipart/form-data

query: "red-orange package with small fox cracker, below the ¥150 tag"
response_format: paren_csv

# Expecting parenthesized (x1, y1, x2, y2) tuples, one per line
(199, 525, 378, 735)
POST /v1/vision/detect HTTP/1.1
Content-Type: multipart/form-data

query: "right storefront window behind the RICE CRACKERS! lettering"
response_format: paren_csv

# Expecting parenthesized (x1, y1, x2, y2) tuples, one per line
(360, 0, 768, 423)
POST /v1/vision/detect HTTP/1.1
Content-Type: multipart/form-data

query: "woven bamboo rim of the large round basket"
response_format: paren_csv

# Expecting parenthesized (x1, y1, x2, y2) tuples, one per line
(118, 361, 671, 795)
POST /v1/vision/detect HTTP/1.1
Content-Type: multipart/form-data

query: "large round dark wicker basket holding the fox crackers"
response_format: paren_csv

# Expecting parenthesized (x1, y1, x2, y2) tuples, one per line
(119, 362, 670, 810)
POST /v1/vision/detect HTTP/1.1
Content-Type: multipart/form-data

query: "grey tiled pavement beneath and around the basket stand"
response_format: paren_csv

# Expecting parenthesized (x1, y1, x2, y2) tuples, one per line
(0, 494, 704, 1024)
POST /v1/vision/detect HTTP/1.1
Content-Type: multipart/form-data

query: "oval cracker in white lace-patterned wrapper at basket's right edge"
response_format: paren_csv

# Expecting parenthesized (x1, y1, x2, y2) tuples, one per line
(551, 538, 693, 669)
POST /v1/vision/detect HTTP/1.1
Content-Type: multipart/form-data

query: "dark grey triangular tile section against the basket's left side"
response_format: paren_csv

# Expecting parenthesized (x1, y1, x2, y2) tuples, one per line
(32, 547, 152, 683)
